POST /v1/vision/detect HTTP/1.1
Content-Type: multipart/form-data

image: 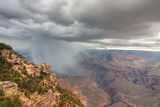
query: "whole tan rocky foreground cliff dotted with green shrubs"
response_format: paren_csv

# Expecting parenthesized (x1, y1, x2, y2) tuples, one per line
(0, 44, 85, 107)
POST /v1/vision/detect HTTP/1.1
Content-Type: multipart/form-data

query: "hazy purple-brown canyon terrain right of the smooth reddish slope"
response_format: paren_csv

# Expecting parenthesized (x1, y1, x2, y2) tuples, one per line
(82, 51, 160, 107)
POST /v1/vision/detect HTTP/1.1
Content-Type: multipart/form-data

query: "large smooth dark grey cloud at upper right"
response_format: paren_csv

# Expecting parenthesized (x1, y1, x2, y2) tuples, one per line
(73, 0, 160, 39)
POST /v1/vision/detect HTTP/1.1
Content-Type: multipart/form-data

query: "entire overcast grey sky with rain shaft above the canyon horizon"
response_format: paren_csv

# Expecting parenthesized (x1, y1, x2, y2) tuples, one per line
(0, 0, 160, 71)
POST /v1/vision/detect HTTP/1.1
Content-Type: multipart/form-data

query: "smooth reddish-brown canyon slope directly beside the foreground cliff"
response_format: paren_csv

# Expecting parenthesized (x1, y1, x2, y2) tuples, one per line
(58, 74, 111, 107)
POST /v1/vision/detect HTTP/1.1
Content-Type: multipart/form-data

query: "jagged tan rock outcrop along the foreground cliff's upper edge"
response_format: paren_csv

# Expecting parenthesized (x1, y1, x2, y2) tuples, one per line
(1, 49, 53, 77)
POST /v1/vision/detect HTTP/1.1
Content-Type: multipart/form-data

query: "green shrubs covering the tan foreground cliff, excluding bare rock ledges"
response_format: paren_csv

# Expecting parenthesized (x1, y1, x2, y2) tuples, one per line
(0, 43, 85, 107)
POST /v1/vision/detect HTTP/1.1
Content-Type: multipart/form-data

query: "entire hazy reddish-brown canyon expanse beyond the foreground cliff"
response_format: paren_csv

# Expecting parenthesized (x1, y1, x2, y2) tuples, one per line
(11, 47, 160, 107)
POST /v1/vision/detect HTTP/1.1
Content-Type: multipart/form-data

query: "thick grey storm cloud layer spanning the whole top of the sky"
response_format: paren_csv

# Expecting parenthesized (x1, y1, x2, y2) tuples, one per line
(0, 0, 160, 42)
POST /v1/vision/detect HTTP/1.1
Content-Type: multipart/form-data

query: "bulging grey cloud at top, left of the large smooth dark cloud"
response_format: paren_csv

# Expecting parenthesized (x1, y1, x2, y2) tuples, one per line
(20, 0, 75, 26)
